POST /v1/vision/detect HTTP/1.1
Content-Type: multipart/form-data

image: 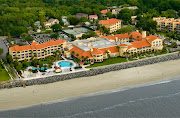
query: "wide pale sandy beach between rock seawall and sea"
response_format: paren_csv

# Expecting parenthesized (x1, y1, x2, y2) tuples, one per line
(0, 60, 180, 110)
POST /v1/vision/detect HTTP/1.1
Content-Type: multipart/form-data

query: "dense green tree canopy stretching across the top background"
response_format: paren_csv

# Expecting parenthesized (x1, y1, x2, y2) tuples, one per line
(0, 0, 180, 36)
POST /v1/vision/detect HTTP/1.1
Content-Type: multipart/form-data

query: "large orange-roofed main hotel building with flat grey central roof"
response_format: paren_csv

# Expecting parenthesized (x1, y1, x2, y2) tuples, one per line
(66, 31, 163, 62)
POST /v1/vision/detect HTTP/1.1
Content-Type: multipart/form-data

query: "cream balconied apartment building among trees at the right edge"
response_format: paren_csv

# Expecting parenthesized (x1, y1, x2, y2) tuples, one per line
(153, 17, 180, 34)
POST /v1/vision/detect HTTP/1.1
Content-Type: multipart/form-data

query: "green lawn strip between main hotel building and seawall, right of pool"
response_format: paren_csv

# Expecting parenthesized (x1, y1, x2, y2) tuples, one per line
(87, 57, 127, 68)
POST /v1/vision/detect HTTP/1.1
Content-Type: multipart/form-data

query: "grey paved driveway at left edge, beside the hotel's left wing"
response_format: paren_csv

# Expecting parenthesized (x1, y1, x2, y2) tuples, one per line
(0, 36, 8, 59)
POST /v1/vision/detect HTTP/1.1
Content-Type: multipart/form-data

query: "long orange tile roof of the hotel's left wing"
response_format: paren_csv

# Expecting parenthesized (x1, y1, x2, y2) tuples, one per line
(10, 39, 66, 51)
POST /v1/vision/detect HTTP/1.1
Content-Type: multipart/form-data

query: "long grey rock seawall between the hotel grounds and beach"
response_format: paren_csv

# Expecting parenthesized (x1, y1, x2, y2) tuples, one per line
(0, 52, 180, 89)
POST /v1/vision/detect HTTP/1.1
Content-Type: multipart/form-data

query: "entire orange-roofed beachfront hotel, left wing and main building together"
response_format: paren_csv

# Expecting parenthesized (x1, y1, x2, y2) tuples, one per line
(9, 31, 163, 62)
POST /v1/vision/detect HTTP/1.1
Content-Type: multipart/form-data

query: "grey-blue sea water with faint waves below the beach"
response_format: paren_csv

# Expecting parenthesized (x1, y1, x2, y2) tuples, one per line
(0, 77, 180, 118)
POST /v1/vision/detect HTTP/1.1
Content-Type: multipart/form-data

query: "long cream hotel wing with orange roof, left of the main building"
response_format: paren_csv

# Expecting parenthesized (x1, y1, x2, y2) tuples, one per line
(9, 39, 67, 61)
